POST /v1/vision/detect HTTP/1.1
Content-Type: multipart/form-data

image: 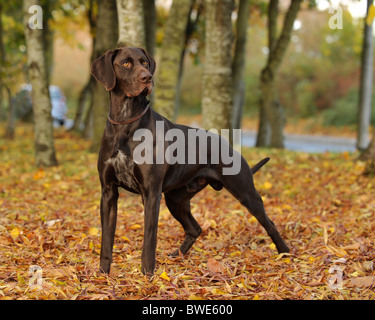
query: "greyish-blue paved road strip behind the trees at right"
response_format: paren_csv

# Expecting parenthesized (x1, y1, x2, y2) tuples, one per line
(242, 130, 356, 153)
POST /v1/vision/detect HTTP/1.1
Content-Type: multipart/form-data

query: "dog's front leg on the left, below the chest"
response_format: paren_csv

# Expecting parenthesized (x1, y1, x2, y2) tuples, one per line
(100, 186, 119, 273)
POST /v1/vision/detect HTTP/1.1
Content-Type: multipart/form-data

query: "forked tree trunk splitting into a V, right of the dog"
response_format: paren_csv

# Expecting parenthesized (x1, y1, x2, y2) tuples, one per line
(257, 0, 302, 148)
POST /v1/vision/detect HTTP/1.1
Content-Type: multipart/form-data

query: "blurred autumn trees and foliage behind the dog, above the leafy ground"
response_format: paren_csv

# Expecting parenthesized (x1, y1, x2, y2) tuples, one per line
(0, 0, 375, 165)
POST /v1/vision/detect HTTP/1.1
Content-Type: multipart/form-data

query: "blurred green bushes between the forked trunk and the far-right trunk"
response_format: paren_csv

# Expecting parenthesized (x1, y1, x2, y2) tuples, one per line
(278, 7, 362, 117)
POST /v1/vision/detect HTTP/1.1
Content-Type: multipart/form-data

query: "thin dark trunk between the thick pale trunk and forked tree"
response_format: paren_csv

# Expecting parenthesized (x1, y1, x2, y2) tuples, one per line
(232, 0, 250, 129)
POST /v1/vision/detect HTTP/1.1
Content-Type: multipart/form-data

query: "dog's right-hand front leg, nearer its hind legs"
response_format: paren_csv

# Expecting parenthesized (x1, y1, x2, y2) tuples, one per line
(142, 192, 161, 274)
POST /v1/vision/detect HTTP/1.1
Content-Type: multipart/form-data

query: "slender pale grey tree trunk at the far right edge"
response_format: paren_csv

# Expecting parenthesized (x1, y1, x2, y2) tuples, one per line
(357, 0, 374, 150)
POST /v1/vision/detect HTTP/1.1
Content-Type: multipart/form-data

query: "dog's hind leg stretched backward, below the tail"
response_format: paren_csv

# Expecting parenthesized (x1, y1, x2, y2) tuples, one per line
(221, 159, 290, 253)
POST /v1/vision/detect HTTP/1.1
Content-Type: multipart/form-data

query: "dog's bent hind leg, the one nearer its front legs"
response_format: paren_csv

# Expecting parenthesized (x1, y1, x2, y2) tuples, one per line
(165, 185, 206, 257)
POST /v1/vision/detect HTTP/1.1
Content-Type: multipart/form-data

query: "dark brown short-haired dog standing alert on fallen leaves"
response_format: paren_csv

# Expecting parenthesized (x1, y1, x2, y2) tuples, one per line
(91, 48, 289, 274)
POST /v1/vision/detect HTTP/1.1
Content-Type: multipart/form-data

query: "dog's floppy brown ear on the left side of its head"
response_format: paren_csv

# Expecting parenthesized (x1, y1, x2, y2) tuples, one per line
(91, 50, 118, 91)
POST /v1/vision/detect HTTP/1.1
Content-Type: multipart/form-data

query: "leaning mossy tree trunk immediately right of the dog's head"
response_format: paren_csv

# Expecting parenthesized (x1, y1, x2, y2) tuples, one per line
(155, 0, 193, 120)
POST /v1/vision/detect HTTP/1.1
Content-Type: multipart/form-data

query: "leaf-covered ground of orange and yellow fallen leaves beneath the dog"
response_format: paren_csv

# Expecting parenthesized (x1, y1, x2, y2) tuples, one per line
(0, 127, 375, 300)
